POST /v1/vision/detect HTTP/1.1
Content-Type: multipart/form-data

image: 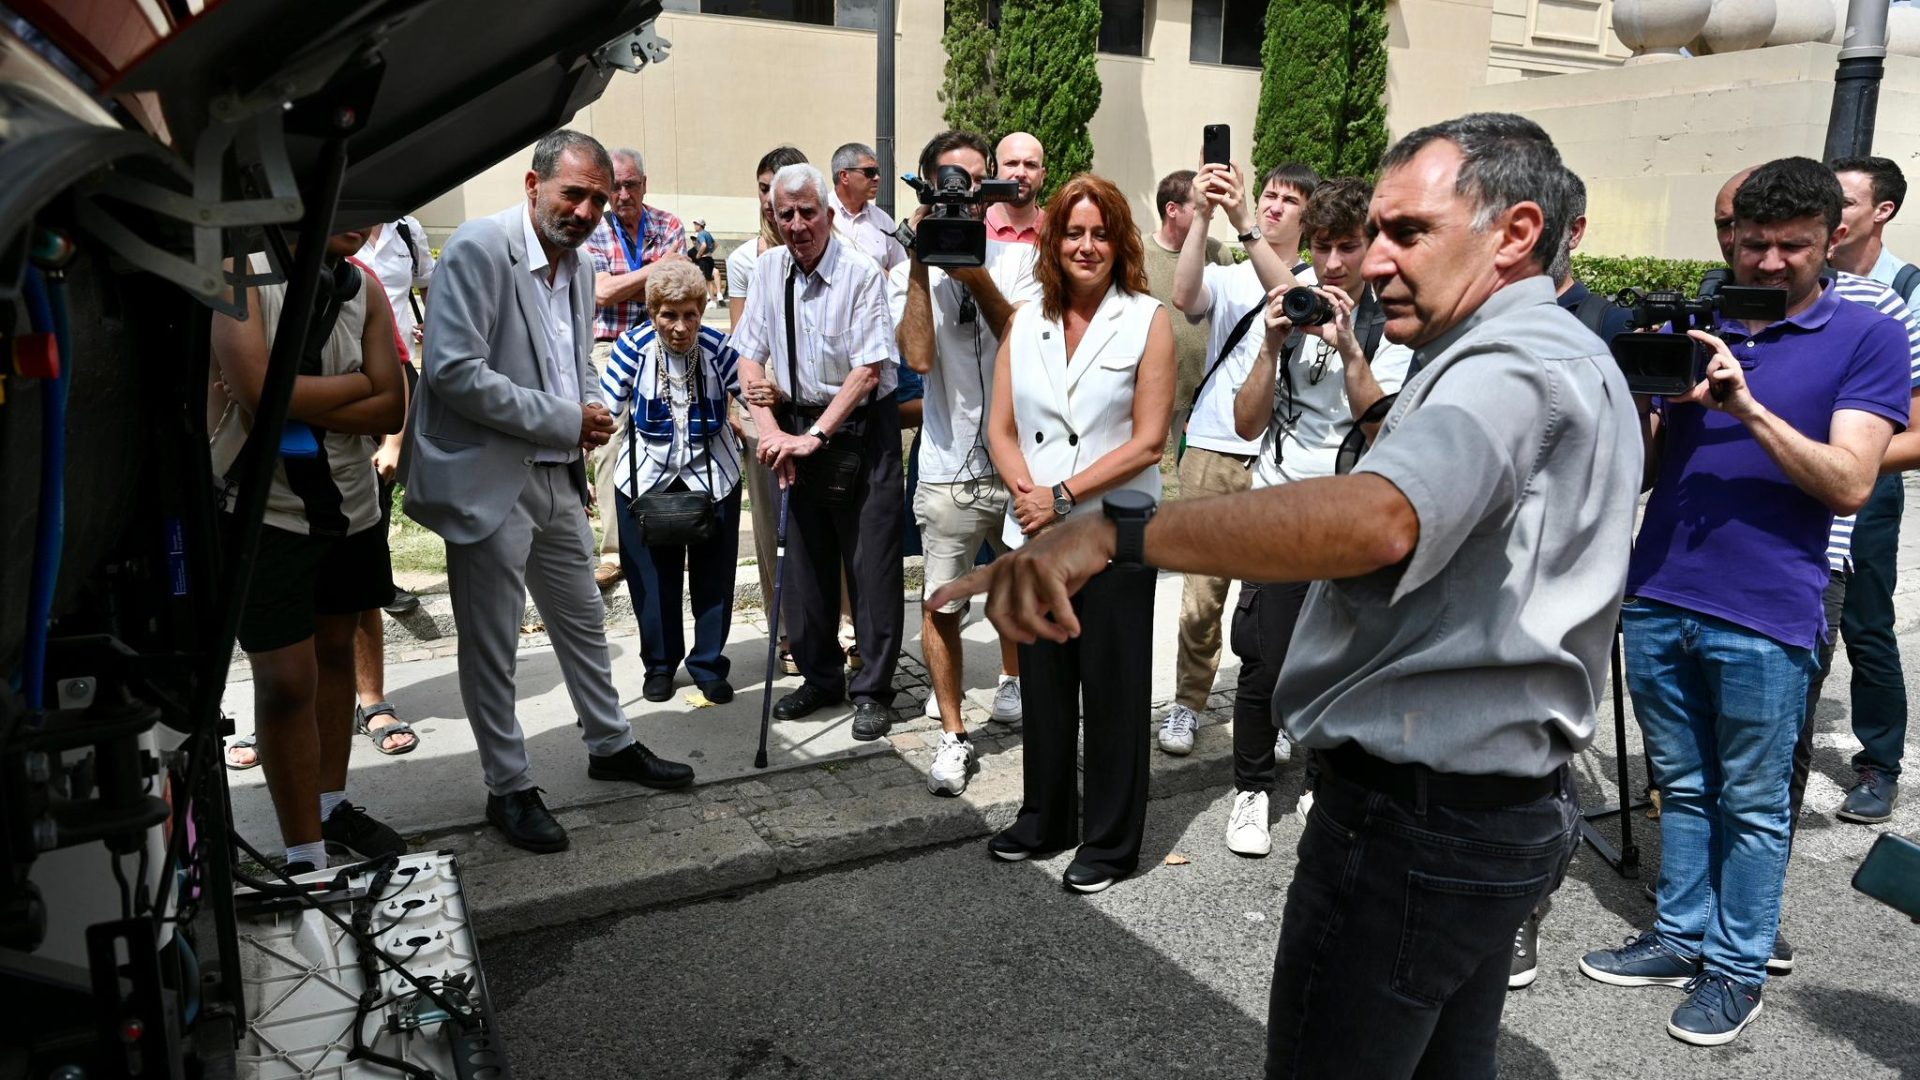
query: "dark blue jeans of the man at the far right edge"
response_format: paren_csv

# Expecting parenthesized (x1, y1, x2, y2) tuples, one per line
(1841, 473, 1907, 778)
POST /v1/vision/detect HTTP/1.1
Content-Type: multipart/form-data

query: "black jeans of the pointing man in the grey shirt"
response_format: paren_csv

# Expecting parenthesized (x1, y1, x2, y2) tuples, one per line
(1267, 753, 1578, 1080)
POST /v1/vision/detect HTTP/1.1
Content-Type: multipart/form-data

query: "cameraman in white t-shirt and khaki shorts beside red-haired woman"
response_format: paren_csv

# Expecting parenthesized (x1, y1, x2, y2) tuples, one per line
(887, 131, 1041, 796)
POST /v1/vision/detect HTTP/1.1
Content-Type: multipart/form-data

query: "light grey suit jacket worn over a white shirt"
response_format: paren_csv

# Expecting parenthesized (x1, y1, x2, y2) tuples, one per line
(405, 204, 601, 544)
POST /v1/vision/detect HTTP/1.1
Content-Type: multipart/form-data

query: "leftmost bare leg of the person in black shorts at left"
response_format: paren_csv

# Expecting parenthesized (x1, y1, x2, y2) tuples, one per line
(248, 638, 322, 847)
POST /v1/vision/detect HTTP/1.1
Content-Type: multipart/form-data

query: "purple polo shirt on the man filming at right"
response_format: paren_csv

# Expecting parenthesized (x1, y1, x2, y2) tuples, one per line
(1626, 281, 1912, 650)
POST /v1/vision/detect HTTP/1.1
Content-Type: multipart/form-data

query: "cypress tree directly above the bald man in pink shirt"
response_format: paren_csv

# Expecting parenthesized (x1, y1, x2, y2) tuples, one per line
(995, 0, 1100, 200)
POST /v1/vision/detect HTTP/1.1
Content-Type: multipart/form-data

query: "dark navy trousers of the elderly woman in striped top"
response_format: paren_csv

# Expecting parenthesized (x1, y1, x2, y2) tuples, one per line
(614, 484, 739, 682)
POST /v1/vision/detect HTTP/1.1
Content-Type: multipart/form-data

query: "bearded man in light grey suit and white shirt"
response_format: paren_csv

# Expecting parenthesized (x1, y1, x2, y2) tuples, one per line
(407, 131, 693, 851)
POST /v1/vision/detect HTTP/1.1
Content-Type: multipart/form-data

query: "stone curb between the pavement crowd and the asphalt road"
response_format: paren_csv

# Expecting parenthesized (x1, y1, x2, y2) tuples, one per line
(445, 715, 1233, 938)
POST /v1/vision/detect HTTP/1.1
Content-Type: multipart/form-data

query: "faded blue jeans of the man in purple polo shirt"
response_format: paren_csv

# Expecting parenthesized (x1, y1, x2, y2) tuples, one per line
(1620, 598, 1818, 986)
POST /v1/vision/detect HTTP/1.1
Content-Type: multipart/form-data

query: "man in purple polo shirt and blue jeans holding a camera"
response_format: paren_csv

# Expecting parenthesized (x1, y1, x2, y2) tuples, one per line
(1580, 158, 1908, 1045)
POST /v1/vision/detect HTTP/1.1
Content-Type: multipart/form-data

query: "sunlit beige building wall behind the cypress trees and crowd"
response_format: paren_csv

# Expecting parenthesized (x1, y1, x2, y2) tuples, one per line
(420, 0, 1626, 246)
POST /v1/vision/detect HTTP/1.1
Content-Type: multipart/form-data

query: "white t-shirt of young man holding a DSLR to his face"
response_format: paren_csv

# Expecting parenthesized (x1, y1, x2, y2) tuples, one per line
(1254, 313, 1413, 488)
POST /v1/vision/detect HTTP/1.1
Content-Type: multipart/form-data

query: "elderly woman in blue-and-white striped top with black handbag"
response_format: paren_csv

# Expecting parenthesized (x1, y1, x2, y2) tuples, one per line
(601, 263, 741, 703)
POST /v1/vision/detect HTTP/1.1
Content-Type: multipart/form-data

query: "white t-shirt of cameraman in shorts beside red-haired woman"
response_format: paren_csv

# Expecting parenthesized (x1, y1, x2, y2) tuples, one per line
(887, 240, 1041, 484)
